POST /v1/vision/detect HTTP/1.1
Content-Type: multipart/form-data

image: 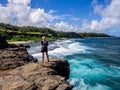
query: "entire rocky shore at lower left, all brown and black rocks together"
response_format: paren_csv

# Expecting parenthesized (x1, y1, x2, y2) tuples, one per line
(0, 36, 73, 90)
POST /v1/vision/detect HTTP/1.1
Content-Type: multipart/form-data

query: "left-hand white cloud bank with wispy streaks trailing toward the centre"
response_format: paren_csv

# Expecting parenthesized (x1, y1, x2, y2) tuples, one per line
(0, 0, 76, 31)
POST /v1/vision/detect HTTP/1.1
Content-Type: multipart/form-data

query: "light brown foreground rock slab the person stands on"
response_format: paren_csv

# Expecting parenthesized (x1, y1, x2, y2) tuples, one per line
(0, 59, 72, 90)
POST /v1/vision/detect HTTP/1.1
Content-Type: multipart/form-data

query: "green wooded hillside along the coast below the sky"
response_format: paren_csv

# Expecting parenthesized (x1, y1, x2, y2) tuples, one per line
(0, 23, 110, 41)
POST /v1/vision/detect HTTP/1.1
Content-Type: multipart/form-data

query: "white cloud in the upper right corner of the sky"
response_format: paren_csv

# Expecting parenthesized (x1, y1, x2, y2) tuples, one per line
(101, 0, 120, 27)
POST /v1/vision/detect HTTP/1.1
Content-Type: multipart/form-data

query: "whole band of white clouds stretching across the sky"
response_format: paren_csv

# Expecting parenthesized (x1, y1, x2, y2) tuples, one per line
(0, 0, 120, 35)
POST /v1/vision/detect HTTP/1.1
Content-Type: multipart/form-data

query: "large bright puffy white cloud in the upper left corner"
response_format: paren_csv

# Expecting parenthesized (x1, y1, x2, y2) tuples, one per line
(0, 0, 52, 26)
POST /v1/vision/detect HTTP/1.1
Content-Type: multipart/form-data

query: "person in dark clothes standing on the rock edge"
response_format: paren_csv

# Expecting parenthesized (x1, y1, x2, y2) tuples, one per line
(41, 36, 49, 63)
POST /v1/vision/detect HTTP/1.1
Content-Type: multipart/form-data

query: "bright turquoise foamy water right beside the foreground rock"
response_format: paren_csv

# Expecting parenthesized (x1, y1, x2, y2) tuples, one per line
(69, 58, 114, 90)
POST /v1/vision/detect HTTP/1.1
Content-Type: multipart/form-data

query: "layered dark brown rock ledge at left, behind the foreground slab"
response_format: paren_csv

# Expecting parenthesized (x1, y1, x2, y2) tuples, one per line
(0, 44, 37, 70)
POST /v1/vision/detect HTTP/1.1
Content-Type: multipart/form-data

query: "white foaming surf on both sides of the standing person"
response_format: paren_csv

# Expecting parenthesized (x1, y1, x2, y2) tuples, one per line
(29, 40, 89, 59)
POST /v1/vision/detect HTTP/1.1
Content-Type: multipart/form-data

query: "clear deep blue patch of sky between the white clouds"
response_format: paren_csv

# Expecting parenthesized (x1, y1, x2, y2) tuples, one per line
(31, 0, 100, 25)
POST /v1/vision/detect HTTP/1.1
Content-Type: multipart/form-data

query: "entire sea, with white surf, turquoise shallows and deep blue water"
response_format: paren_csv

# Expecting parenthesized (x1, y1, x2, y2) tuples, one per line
(28, 38, 120, 90)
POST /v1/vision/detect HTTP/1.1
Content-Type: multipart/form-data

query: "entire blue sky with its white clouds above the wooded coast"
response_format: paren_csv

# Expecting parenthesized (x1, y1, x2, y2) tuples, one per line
(0, 0, 120, 36)
